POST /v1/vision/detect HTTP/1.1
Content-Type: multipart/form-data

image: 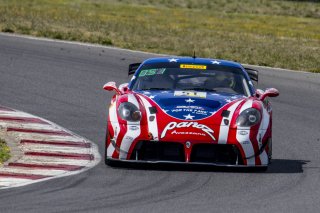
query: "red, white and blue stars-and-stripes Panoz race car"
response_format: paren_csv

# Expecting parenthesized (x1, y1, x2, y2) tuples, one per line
(103, 57, 279, 169)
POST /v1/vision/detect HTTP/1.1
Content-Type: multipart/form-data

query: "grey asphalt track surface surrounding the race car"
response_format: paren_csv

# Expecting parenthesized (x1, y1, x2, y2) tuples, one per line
(0, 35, 320, 213)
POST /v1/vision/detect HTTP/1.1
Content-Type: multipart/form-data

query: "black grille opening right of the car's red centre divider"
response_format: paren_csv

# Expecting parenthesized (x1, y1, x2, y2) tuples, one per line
(190, 144, 243, 165)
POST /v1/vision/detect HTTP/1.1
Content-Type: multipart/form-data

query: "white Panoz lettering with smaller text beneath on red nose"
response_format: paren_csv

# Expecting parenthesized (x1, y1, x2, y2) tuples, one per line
(161, 121, 216, 140)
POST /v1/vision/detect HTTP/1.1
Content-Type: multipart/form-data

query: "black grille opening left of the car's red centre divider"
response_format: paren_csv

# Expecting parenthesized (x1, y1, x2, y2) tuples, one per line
(130, 141, 185, 162)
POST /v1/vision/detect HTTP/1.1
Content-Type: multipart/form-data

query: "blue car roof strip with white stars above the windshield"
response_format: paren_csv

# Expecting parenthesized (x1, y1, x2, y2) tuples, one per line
(144, 57, 242, 69)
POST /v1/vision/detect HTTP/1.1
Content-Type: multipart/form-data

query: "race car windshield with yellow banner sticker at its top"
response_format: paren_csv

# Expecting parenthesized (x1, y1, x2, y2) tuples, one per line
(131, 63, 250, 96)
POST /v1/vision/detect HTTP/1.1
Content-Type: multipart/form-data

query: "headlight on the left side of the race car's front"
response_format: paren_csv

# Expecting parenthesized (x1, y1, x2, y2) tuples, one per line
(118, 102, 141, 121)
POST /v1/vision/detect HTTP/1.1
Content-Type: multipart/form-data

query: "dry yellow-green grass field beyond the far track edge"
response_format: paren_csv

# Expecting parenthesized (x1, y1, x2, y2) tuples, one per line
(0, 0, 320, 72)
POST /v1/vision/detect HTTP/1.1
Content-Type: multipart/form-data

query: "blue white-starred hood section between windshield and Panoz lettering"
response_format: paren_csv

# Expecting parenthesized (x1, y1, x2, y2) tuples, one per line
(135, 90, 245, 120)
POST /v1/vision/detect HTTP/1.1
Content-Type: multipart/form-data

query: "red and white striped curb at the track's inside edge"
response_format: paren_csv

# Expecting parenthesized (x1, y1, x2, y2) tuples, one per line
(0, 106, 101, 189)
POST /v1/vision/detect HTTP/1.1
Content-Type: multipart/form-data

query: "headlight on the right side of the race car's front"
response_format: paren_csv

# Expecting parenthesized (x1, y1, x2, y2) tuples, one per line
(237, 108, 261, 127)
